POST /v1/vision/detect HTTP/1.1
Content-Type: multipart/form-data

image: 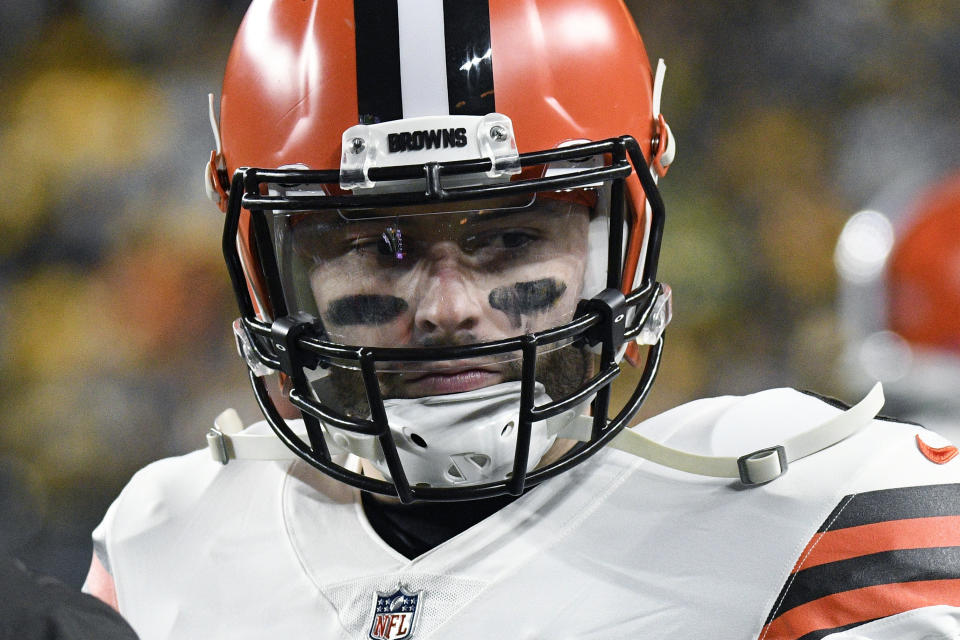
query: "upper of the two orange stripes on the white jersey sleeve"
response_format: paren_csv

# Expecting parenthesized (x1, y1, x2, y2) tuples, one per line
(793, 516, 960, 573)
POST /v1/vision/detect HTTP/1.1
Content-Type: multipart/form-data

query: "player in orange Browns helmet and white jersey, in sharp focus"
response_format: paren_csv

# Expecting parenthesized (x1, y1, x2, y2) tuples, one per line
(80, 0, 960, 640)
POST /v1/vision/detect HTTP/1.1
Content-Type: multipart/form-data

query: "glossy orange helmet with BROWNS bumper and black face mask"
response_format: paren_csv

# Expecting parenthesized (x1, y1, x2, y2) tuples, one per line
(205, 0, 675, 502)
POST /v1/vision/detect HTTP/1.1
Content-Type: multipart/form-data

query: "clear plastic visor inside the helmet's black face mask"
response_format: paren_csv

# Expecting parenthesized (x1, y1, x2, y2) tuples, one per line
(271, 185, 609, 376)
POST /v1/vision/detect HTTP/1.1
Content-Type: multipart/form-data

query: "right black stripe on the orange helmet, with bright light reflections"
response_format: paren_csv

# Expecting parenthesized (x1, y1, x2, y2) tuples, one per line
(443, 0, 496, 115)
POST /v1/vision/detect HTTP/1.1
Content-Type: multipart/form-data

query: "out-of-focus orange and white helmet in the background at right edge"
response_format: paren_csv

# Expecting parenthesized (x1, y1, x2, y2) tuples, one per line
(835, 171, 960, 436)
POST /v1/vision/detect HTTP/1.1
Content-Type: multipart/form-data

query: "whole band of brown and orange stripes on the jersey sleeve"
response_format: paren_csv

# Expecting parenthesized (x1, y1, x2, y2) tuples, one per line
(758, 484, 960, 640)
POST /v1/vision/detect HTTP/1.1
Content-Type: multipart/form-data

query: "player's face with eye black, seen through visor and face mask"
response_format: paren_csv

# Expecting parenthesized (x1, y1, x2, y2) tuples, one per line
(293, 195, 590, 397)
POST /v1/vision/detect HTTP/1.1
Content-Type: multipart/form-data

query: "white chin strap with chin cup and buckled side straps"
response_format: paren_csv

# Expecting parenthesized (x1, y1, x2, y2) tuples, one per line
(207, 382, 884, 486)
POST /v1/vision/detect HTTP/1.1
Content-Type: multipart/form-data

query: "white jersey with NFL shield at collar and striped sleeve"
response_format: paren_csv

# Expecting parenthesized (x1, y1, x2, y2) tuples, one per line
(86, 389, 960, 640)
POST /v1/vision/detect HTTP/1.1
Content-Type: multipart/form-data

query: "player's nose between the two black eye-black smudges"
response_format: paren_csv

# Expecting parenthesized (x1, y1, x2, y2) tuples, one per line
(414, 242, 483, 340)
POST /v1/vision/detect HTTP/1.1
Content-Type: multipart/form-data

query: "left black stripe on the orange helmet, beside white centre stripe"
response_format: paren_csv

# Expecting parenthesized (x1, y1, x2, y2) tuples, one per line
(353, 0, 403, 124)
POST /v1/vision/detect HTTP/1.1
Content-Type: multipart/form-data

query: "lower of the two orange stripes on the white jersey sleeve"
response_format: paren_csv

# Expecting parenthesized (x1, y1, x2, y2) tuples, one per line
(759, 579, 960, 640)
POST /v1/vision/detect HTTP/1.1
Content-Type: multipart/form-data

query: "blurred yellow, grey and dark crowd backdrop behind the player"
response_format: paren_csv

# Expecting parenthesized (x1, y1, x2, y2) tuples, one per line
(0, 0, 960, 586)
